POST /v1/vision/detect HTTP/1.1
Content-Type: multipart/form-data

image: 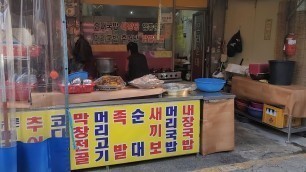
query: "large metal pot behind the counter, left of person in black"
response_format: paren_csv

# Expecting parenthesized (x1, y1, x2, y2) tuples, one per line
(96, 57, 115, 74)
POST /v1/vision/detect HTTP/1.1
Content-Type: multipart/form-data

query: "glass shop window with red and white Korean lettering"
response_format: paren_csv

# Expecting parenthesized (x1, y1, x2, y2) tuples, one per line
(81, 4, 173, 51)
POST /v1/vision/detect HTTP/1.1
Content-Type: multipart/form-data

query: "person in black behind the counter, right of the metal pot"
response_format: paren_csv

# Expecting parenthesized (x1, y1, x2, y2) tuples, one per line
(127, 42, 150, 81)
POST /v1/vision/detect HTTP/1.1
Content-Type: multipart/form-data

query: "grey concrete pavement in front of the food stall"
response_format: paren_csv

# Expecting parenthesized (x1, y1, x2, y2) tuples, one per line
(77, 121, 306, 172)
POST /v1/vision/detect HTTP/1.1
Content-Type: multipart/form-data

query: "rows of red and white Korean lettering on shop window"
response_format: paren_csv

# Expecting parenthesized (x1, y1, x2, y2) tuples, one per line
(82, 15, 172, 45)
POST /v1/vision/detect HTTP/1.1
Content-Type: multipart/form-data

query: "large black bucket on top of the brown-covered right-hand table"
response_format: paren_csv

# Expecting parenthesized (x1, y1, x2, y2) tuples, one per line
(269, 60, 295, 85)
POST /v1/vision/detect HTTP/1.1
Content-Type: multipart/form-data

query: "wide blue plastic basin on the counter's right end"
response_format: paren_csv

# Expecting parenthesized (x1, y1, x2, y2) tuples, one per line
(195, 78, 225, 92)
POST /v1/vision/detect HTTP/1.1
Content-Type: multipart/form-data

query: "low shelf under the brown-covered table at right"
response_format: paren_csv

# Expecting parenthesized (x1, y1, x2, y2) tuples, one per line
(235, 109, 306, 133)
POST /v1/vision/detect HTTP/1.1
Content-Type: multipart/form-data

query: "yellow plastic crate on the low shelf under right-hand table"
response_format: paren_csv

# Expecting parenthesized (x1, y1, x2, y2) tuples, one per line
(262, 104, 302, 128)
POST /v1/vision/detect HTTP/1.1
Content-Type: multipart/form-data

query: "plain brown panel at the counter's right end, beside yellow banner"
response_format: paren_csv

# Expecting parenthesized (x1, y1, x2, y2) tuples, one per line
(200, 99, 235, 155)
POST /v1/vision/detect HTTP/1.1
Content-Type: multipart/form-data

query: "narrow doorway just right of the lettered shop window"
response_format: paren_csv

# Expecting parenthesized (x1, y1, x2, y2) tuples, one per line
(174, 10, 205, 81)
